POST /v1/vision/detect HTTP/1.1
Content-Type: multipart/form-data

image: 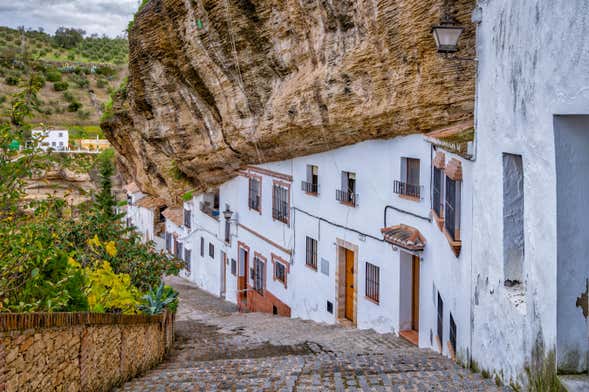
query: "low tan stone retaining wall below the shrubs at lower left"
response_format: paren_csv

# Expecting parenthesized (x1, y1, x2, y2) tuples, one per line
(0, 313, 174, 392)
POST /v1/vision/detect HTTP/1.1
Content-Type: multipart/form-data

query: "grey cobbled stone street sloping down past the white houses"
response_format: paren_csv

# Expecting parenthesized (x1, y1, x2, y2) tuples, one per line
(119, 278, 506, 392)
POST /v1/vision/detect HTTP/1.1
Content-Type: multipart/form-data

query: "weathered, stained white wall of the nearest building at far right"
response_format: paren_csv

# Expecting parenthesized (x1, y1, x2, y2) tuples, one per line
(472, 0, 589, 383)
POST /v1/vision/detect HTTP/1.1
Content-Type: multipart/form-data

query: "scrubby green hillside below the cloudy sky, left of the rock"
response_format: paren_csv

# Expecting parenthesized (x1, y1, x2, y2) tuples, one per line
(0, 27, 128, 130)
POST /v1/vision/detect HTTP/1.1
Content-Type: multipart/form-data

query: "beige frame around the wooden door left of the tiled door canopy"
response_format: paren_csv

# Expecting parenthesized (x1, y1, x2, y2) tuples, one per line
(335, 238, 359, 326)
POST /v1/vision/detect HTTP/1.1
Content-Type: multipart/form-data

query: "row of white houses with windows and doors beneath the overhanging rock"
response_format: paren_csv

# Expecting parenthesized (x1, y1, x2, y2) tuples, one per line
(133, 131, 472, 362)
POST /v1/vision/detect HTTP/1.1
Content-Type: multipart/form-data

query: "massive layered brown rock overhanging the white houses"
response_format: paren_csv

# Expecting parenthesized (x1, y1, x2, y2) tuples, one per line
(103, 0, 475, 200)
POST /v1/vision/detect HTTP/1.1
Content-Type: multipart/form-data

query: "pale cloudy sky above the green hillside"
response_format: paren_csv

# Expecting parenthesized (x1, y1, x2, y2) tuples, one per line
(0, 0, 138, 37)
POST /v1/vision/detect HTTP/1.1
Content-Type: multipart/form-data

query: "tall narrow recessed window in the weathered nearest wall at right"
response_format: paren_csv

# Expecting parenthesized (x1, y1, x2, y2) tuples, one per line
(503, 154, 525, 287)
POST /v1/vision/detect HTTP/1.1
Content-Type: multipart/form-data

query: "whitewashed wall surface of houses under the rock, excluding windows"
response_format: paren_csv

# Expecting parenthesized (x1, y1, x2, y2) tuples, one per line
(134, 135, 472, 362)
